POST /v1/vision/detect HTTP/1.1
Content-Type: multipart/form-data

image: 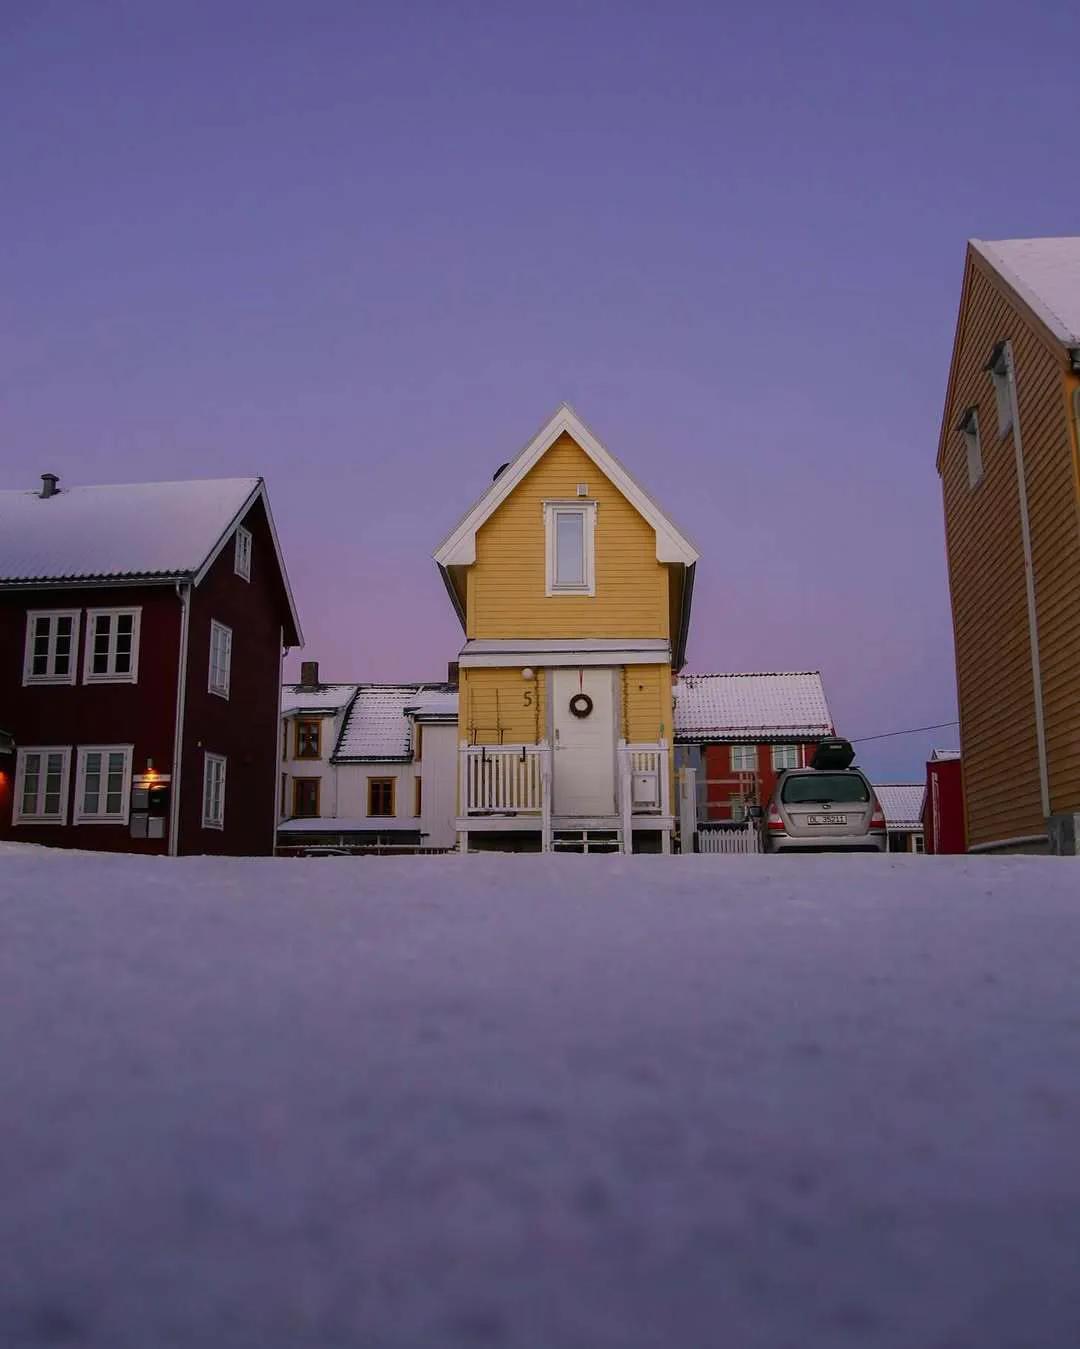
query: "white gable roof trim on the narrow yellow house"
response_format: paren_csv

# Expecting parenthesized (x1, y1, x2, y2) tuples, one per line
(434, 403, 700, 567)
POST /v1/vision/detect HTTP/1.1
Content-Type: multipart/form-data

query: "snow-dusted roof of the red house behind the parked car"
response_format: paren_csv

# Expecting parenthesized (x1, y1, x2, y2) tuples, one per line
(676, 670, 835, 741)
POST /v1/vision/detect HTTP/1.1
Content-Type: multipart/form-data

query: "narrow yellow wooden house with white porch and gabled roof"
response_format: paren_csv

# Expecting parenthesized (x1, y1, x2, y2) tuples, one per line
(434, 403, 698, 851)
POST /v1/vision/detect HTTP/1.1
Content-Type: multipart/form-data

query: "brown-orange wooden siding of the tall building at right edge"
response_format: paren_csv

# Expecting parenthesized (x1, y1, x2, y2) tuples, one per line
(940, 254, 1080, 846)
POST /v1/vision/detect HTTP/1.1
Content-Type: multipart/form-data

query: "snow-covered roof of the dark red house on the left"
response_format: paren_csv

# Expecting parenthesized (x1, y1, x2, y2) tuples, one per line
(0, 478, 260, 581)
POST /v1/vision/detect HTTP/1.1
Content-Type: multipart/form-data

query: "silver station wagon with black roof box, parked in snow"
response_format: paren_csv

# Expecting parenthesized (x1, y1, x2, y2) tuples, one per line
(760, 739, 889, 853)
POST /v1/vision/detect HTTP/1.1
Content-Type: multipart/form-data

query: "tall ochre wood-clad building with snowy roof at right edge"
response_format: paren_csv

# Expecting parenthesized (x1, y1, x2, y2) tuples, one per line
(937, 237, 1080, 854)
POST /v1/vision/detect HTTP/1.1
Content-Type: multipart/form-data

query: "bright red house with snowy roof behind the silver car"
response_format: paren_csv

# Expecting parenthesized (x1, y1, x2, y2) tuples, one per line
(674, 670, 836, 823)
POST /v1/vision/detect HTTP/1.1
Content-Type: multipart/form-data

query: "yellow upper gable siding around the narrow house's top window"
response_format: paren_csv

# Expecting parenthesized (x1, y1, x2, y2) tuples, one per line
(467, 436, 670, 638)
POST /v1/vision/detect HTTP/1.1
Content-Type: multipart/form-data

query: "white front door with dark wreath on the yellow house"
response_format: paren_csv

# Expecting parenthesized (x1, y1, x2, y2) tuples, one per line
(551, 666, 615, 815)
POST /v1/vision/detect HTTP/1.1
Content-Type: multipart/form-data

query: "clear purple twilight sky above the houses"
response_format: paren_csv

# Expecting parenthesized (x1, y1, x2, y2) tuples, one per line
(0, 0, 1080, 780)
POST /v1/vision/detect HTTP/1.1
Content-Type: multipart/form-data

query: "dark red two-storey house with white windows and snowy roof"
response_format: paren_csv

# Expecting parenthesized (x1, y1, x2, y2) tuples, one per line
(0, 473, 302, 855)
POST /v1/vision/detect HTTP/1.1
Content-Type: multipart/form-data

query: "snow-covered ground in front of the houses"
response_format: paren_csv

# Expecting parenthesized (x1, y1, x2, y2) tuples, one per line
(0, 847, 1080, 1349)
